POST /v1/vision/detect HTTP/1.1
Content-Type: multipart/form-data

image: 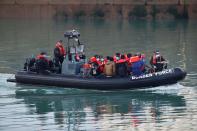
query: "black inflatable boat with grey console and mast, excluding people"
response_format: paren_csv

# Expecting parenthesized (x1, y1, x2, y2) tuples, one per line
(7, 30, 186, 90)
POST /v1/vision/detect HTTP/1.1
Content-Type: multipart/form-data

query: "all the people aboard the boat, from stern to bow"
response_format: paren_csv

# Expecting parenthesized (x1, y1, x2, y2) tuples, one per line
(24, 40, 167, 77)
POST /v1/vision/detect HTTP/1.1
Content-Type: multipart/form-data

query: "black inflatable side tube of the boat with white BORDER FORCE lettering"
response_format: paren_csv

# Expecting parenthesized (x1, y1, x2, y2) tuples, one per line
(12, 68, 186, 90)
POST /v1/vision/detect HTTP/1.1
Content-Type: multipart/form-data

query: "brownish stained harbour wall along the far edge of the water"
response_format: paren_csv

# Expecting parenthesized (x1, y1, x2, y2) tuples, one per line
(0, 0, 197, 19)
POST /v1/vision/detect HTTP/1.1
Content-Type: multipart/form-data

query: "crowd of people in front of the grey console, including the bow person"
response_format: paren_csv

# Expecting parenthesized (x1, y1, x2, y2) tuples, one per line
(84, 51, 167, 77)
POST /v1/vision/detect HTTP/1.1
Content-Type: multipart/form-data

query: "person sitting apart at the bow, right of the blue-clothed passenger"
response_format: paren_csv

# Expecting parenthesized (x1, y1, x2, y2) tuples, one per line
(150, 51, 167, 72)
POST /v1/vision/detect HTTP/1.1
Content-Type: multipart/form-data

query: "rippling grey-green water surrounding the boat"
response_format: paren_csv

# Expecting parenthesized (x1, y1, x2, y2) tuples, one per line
(0, 19, 197, 131)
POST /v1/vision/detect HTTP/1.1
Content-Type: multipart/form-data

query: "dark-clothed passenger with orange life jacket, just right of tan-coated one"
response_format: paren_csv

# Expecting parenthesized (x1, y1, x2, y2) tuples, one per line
(116, 55, 128, 77)
